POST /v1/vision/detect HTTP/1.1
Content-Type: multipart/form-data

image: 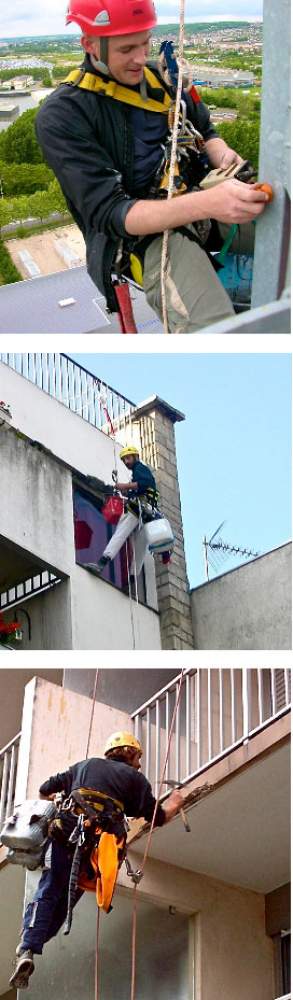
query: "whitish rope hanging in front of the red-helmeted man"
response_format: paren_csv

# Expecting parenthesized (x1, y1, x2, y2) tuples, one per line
(161, 0, 185, 333)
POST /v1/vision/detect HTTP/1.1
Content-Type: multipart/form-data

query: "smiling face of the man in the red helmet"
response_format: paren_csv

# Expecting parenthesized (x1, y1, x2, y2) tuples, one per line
(82, 31, 151, 87)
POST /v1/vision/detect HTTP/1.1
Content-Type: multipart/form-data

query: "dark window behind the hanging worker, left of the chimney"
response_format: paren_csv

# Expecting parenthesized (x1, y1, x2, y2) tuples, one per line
(73, 487, 146, 604)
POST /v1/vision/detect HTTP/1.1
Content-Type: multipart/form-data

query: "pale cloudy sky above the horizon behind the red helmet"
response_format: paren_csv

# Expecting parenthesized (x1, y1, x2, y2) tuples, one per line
(1, 0, 262, 38)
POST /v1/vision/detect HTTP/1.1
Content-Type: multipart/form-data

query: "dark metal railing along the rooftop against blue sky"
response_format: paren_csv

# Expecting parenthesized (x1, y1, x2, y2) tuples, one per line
(0, 353, 135, 431)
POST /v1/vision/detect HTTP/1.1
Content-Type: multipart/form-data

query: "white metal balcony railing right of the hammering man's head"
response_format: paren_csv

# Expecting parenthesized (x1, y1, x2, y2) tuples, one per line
(132, 668, 291, 787)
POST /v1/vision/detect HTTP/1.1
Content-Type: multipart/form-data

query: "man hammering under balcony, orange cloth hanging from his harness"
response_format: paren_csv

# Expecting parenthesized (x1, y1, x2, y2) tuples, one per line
(10, 732, 183, 989)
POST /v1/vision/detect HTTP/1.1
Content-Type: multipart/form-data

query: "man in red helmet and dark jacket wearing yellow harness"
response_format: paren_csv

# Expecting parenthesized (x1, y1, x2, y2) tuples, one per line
(36, 0, 269, 333)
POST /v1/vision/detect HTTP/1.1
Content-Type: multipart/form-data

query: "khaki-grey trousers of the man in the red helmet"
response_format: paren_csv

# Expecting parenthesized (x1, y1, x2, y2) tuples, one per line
(144, 224, 254, 333)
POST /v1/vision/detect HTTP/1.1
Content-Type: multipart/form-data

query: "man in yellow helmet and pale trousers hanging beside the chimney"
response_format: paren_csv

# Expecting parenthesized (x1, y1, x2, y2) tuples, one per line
(85, 445, 159, 577)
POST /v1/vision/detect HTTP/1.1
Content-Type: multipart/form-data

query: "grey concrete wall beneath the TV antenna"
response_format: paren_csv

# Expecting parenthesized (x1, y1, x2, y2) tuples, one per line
(191, 543, 292, 649)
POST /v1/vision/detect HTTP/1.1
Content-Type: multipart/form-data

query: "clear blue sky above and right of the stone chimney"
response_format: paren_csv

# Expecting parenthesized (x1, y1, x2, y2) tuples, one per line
(71, 354, 291, 586)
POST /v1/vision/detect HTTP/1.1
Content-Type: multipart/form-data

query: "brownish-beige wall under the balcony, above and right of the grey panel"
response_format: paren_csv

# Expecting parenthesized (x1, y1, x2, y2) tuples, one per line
(119, 851, 274, 1000)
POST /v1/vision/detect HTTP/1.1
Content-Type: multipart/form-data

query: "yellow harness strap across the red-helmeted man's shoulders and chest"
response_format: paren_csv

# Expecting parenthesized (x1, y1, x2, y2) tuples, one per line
(63, 66, 174, 114)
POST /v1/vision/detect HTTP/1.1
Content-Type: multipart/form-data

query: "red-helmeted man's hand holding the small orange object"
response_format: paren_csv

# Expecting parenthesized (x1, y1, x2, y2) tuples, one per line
(203, 180, 269, 225)
